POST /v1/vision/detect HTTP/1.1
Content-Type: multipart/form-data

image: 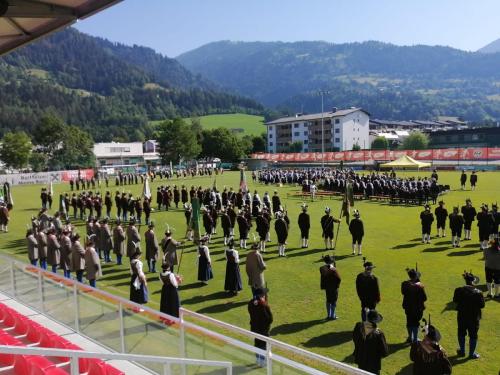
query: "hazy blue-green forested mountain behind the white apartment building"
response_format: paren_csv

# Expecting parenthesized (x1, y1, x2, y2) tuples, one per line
(177, 41, 500, 121)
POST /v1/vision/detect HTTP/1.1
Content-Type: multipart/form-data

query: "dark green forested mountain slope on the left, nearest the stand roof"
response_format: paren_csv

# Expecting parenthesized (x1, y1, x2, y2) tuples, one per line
(0, 29, 263, 141)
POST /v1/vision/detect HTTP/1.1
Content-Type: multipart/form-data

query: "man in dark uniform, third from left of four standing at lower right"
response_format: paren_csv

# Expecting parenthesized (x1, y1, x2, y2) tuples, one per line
(401, 268, 427, 343)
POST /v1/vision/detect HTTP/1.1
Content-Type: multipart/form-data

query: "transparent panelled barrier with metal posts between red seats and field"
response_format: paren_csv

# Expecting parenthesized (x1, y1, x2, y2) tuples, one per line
(0, 255, 369, 375)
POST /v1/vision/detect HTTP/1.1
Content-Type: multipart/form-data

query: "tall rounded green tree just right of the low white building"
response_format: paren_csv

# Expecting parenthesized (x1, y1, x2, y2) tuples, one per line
(156, 118, 201, 164)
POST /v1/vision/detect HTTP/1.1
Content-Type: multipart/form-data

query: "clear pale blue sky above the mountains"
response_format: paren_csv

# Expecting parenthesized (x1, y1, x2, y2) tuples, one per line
(77, 0, 500, 57)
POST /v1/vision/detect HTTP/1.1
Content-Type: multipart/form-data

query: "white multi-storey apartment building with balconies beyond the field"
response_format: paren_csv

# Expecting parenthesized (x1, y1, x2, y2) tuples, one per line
(266, 108, 370, 153)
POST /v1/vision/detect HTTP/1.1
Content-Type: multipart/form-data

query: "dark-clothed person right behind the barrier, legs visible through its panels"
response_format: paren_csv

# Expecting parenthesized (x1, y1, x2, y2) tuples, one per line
(248, 288, 273, 367)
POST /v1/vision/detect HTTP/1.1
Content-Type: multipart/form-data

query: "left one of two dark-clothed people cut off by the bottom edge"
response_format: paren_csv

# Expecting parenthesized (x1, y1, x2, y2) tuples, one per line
(352, 310, 389, 374)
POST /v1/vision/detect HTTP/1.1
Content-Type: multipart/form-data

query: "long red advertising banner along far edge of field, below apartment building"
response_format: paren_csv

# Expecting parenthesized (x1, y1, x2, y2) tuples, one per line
(252, 147, 500, 162)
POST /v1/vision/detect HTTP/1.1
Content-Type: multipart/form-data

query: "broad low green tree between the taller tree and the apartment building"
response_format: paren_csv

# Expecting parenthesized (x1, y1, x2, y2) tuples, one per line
(202, 128, 244, 162)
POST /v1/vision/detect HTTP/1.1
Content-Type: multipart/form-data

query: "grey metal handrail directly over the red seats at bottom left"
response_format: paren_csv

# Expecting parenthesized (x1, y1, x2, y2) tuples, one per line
(0, 345, 233, 375)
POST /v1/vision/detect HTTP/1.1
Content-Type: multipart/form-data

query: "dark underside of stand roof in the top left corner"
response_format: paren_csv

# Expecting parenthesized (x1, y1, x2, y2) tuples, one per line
(0, 0, 122, 55)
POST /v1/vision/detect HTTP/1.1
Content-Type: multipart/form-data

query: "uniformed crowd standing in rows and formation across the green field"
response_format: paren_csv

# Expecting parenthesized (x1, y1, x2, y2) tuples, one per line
(20, 169, 500, 374)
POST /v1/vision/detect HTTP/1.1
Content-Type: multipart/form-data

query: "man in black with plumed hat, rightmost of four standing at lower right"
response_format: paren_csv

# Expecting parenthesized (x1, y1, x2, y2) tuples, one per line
(453, 272, 484, 359)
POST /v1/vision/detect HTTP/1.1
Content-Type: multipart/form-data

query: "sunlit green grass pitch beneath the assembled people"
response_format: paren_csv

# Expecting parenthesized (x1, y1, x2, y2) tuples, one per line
(0, 172, 500, 374)
